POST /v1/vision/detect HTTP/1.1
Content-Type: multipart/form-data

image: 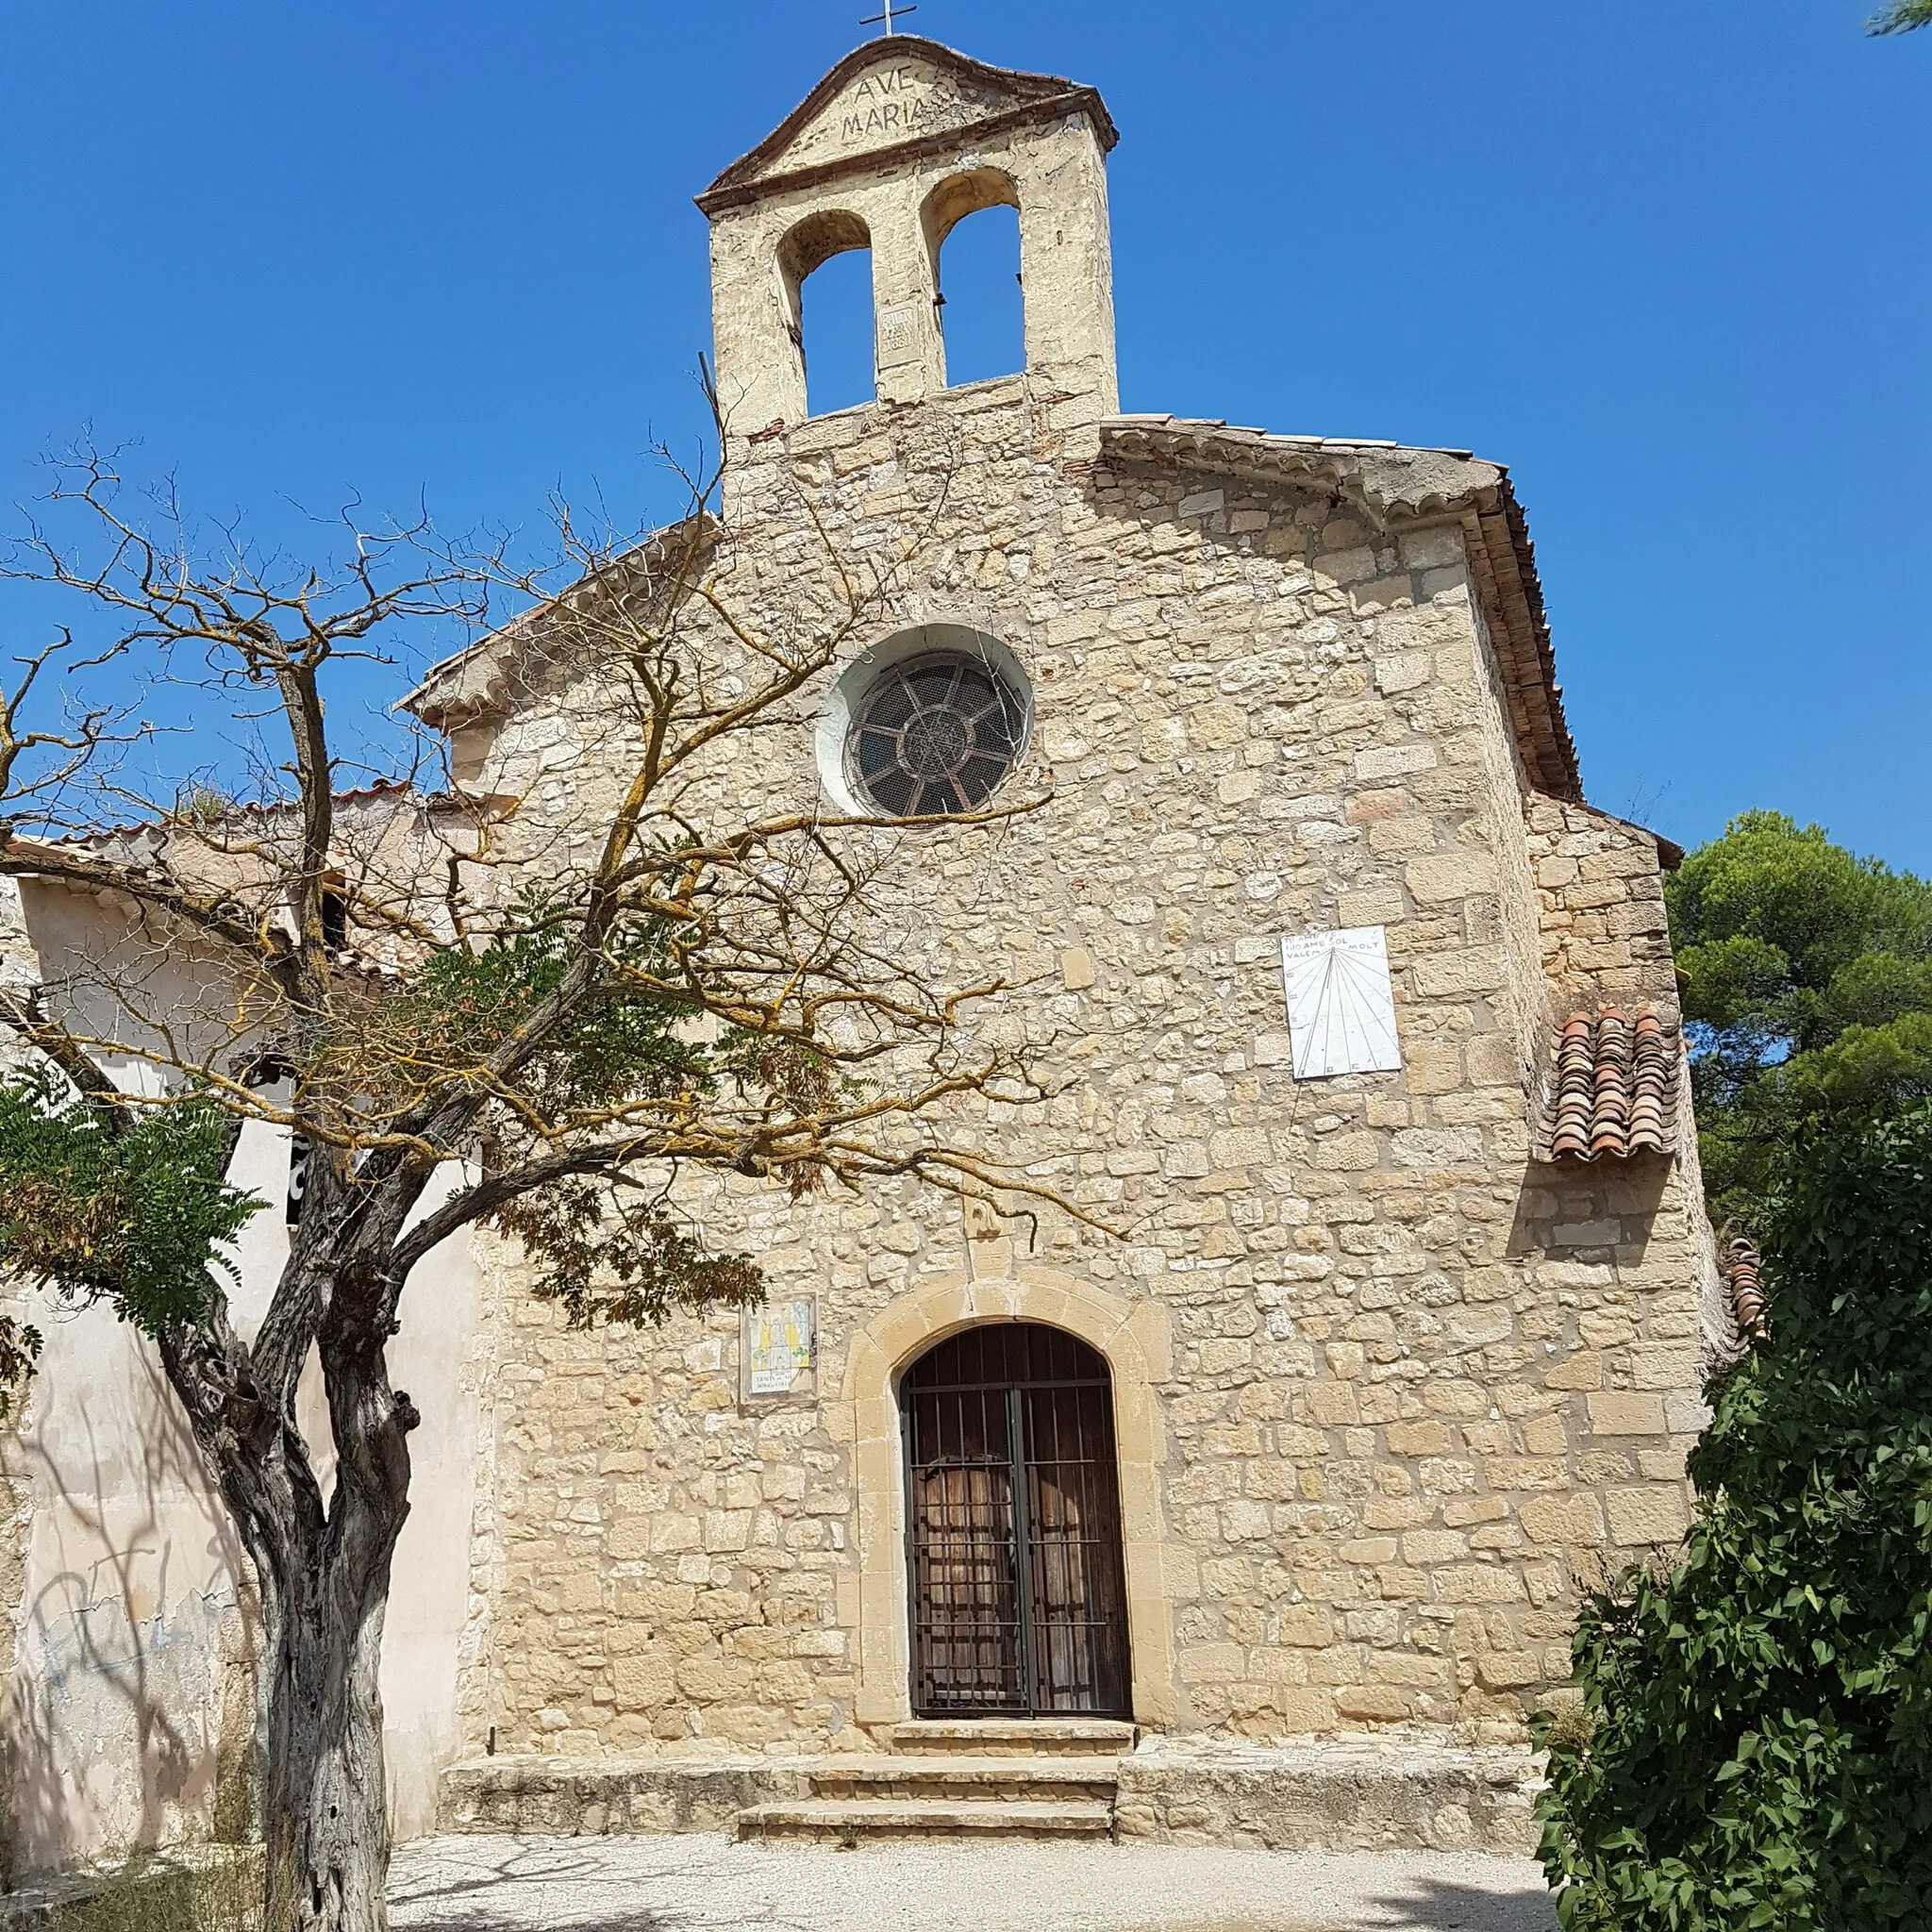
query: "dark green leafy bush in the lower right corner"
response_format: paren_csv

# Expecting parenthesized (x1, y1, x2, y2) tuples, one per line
(1540, 1109, 1932, 1932)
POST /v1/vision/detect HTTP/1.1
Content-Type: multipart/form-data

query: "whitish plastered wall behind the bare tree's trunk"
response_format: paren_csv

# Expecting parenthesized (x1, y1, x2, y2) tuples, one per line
(8, 887, 477, 1870)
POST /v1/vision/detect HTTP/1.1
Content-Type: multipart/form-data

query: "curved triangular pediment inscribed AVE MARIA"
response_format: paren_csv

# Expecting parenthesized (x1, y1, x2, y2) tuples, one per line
(697, 35, 1117, 212)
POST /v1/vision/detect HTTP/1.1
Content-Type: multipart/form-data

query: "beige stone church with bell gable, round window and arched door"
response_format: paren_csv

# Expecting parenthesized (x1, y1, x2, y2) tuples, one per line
(0, 37, 1724, 1845)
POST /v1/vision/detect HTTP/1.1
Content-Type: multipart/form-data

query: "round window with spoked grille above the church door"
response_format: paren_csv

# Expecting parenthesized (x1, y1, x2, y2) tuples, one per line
(846, 653, 1025, 819)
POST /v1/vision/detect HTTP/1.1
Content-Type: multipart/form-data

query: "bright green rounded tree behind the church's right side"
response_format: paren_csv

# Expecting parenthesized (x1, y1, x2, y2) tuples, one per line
(1665, 811, 1932, 1224)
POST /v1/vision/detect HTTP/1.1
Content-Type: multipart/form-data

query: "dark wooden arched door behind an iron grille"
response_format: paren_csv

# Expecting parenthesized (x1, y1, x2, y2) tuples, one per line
(900, 1322, 1132, 1718)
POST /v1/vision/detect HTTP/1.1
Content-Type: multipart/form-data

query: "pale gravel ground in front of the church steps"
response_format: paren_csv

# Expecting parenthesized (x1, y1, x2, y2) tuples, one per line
(391, 1834, 1556, 1932)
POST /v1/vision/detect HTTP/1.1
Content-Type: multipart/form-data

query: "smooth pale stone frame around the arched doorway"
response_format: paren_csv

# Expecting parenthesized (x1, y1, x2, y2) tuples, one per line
(827, 1267, 1192, 1729)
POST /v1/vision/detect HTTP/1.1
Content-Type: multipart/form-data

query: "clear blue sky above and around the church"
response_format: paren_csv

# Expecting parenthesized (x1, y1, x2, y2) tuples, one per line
(0, 0, 1932, 872)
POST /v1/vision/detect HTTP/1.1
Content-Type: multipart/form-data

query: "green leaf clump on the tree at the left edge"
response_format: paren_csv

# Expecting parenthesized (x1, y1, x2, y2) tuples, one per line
(0, 1071, 260, 1349)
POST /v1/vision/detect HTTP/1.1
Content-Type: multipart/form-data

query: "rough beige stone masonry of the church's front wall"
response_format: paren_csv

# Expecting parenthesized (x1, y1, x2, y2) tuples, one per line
(441, 378, 1707, 1757)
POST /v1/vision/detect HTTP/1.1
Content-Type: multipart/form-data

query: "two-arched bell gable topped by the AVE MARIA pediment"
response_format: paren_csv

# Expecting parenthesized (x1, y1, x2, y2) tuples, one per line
(697, 35, 1119, 439)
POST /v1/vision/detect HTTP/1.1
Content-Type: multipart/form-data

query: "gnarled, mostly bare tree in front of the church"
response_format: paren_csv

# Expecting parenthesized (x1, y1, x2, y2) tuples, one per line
(0, 441, 1041, 1932)
